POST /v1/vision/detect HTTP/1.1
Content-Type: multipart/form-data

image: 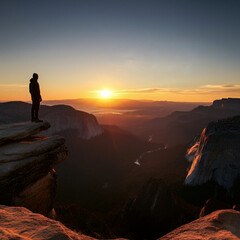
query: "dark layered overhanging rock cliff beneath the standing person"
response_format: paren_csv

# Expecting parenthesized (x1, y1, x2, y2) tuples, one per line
(0, 122, 67, 216)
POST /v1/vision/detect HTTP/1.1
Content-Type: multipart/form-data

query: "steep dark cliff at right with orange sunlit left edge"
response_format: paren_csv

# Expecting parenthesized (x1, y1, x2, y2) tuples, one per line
(185, 117, 240, 190)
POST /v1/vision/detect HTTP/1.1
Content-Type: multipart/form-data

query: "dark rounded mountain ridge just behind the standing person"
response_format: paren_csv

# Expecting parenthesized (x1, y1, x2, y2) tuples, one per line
(0, 102, 103, 139)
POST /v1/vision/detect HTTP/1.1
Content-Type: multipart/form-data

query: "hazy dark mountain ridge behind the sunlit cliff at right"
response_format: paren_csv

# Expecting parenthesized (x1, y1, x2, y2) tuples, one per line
(139, 98, 240, 145)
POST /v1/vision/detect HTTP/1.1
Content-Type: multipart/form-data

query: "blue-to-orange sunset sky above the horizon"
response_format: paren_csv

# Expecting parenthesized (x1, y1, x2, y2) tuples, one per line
(0, 0, 240, 102)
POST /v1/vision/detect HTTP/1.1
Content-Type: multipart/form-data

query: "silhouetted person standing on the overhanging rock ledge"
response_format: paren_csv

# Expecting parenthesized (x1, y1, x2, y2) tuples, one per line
(29, 73, 42, 122)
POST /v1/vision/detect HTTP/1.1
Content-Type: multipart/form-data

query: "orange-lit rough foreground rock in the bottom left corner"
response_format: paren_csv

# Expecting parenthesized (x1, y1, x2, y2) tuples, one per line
(0, 205, 93, 240)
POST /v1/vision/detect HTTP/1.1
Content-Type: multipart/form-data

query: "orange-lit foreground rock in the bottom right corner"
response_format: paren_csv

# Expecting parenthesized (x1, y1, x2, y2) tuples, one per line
(159, 210, 240, 240)
